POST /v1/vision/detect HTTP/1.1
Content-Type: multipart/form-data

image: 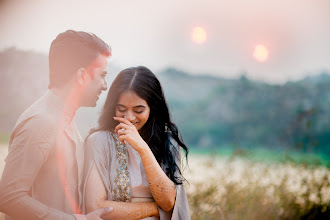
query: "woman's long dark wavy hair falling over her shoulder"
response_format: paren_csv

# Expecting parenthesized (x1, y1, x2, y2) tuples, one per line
(89, 66, 189, 185)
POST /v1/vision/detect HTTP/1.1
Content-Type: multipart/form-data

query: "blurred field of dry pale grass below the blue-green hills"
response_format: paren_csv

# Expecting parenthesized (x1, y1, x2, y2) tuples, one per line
(0, 144, 330, 220)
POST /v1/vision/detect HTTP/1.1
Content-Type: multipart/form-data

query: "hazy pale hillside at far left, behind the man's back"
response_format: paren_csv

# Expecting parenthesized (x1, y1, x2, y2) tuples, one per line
(0, 48, 49, 133)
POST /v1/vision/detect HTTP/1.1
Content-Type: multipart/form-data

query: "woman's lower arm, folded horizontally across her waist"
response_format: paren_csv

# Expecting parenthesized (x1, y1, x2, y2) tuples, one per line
(85, 164, 159, 220)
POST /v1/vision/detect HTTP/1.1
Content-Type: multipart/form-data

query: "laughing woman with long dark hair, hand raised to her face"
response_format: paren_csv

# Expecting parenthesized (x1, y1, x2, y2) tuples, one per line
(83, 67, 190, 220)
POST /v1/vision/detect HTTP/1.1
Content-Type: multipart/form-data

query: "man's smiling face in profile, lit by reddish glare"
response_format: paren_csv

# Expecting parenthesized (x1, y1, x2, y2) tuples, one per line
(80, 54, 108, 107)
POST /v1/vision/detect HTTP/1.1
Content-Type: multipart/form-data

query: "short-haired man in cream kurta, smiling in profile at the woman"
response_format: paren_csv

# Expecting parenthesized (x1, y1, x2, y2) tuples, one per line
(0, 30, 112, 220)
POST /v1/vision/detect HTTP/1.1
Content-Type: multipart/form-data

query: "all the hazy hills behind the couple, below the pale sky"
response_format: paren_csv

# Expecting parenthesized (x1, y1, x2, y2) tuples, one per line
(0, 48, 330, 154)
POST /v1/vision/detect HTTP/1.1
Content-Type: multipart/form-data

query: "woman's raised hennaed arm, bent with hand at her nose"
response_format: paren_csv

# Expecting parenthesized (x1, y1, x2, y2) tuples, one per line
(114, 117, 176, 212)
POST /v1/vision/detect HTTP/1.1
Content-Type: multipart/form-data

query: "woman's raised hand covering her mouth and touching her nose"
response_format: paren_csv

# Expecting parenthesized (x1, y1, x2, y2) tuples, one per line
(113, 117, 149, 153)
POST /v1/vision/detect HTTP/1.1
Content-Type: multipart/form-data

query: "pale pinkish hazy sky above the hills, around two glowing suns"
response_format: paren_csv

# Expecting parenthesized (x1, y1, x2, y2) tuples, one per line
(0, 0, 330, 83)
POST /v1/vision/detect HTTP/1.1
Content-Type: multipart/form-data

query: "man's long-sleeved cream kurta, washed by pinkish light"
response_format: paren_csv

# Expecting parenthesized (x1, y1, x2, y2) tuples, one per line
(0, 90, 84, 220)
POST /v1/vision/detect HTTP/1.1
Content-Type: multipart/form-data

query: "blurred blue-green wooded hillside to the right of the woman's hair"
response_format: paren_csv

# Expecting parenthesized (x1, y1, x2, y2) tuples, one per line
(163, 70, 330, 154)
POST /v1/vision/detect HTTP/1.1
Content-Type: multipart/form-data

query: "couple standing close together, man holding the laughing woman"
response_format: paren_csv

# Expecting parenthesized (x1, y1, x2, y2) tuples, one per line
(0, 30, 190, 220)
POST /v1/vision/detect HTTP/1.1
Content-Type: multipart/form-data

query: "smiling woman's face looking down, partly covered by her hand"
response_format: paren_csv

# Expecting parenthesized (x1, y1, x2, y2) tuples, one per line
(116, 91, 150, 130)
